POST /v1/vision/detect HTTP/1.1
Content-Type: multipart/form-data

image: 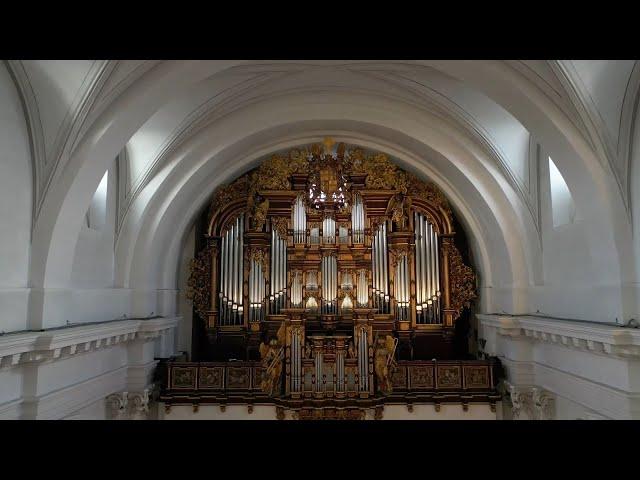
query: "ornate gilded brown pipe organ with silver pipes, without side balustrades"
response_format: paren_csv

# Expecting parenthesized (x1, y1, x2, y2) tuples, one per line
(190, 140, 475, 408)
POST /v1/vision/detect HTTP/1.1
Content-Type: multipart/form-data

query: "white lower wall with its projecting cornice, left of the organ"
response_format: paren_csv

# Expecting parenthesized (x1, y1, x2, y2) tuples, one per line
(0, 318, 179, 419)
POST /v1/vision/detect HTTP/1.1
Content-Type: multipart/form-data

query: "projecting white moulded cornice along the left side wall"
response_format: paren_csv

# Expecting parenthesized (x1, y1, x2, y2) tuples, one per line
(0, 317, 180, 369)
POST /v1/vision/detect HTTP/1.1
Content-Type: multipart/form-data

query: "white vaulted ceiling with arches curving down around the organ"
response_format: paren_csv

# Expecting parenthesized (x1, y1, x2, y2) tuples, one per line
(7, 60, 638, 330)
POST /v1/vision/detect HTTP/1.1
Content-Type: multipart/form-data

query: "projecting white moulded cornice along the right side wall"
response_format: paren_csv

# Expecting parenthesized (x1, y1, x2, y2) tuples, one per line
(476, 314, 640, 359)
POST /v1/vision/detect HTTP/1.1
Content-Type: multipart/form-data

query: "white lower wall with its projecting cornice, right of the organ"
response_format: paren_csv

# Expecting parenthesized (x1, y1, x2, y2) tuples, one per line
(477, 314, 640, 420)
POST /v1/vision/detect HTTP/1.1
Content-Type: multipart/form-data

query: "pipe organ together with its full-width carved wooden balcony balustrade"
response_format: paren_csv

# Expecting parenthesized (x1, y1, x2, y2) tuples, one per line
(161, 138, 500, 419)
